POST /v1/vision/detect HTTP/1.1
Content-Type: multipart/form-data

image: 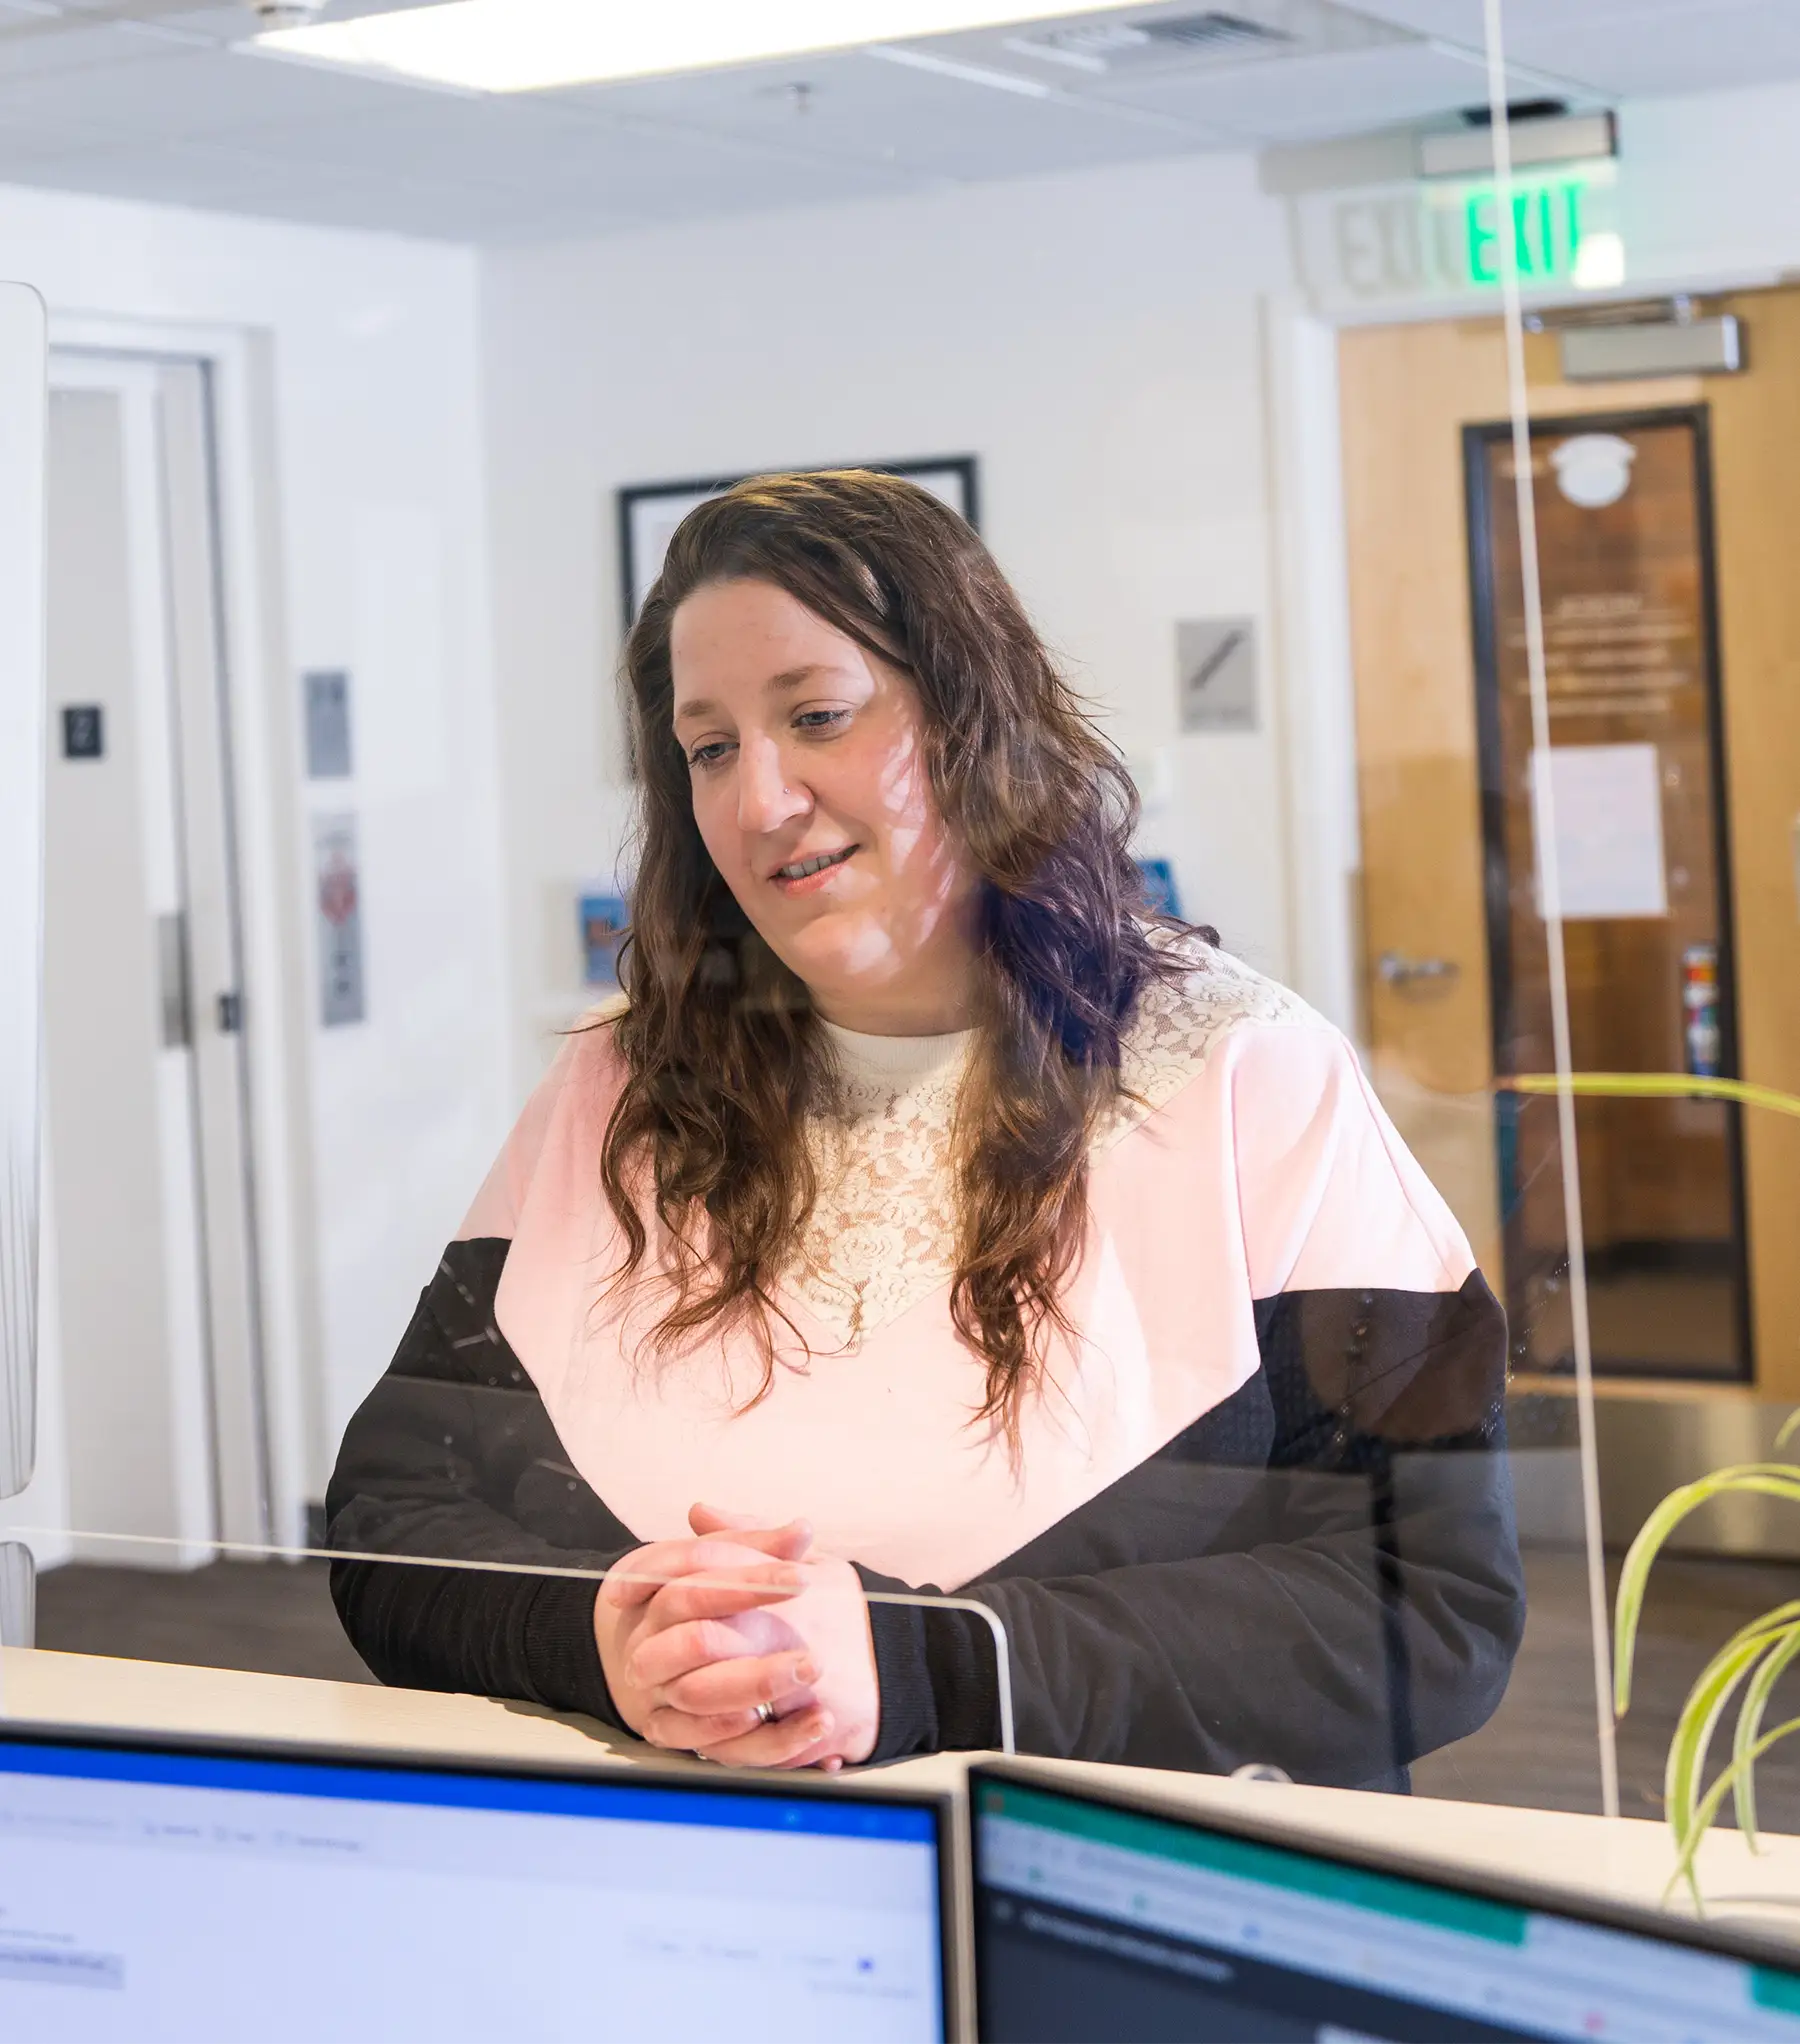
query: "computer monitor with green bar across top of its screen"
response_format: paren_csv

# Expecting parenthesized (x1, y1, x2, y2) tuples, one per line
(968, 1768, 1800, 2044)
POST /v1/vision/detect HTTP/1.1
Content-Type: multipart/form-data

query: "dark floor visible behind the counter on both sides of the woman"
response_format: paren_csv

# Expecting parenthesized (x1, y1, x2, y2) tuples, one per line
(37, 1551, 1800, 1831)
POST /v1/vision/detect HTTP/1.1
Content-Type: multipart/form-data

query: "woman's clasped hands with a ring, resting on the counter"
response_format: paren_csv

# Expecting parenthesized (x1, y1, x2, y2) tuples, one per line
(595, 1504, 881, 1772)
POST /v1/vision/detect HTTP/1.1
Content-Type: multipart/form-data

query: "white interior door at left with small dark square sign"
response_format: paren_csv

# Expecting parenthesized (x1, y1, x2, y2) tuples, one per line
(45, 358, 266, 1566)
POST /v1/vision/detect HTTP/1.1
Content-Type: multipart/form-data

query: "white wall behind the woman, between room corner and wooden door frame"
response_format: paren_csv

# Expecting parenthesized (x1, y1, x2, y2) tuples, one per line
(482, 157, 1289, 1083)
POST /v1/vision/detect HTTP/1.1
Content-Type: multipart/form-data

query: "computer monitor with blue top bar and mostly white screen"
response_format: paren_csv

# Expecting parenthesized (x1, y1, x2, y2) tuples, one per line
(0, 1731, 948, 2044)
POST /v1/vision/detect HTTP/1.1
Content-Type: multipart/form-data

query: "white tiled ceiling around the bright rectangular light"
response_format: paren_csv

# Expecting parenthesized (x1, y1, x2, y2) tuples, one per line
(0, 0, 1800, 241)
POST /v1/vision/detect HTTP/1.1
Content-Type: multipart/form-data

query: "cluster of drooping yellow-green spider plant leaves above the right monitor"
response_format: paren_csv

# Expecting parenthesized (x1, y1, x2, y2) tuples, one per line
(1612, 1412, 1800, 1911)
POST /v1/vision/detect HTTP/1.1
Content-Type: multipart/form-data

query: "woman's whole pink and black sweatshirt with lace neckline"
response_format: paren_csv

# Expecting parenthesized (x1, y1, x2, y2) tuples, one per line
(327, 950, 1524, 1786)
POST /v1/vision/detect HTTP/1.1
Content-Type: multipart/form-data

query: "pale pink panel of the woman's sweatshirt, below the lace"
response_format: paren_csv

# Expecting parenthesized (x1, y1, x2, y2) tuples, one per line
(464, 1005, 1469, 1588)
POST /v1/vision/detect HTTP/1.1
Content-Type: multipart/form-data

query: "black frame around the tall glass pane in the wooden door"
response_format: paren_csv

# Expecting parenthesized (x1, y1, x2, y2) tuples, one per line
(1463, 405, 1755, 1386)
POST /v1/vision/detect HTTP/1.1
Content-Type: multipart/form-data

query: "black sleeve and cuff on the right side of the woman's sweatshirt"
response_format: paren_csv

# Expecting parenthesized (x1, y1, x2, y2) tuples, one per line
(866, 1273, 1524, 1786)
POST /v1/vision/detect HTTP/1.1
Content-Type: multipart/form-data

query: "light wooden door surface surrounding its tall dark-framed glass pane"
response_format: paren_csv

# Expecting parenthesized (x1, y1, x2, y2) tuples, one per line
(1340, 292, 1800, 1396)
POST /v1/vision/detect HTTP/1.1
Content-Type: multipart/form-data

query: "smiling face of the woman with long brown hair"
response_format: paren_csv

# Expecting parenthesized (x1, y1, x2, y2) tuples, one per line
(670, 580, 975, 1036)
